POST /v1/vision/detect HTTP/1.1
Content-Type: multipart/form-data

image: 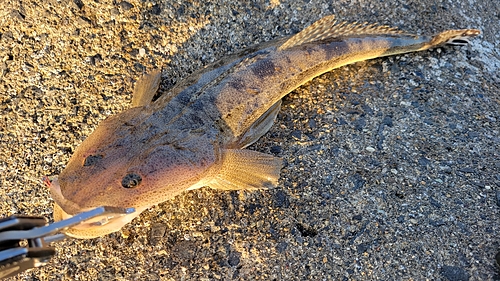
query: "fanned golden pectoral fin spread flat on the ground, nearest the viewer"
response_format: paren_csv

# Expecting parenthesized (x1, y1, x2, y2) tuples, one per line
(208, 149, 282, 190)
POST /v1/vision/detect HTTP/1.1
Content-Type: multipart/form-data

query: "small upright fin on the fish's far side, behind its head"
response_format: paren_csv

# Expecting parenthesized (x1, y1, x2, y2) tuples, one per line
(132, 70, 161, 107)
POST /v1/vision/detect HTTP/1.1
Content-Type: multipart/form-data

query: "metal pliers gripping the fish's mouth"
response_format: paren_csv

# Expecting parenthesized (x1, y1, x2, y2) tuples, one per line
(0, 207, 135, 279)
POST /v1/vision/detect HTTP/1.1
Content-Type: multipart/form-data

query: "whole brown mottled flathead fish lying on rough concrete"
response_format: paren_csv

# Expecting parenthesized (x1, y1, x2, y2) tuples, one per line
(48, 15, 480, 239)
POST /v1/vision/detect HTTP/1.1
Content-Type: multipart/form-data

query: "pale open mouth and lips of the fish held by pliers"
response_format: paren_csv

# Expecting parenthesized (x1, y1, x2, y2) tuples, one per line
(49, 178, 147, 239)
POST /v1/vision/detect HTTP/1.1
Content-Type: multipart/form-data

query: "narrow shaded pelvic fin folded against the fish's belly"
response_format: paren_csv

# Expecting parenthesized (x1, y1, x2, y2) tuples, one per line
(233, 100, 281, 148)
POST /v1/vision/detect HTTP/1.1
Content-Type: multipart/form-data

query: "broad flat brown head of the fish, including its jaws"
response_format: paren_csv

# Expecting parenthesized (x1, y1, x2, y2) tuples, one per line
(49, 108, 216, 239)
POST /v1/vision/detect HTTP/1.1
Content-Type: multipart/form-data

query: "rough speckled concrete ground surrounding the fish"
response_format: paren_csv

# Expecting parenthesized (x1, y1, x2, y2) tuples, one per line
(0, 0, 500, 280)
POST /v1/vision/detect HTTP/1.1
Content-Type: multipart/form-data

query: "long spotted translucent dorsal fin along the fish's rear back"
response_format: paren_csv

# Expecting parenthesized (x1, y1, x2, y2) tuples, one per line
(279, 15, 404, 50)
